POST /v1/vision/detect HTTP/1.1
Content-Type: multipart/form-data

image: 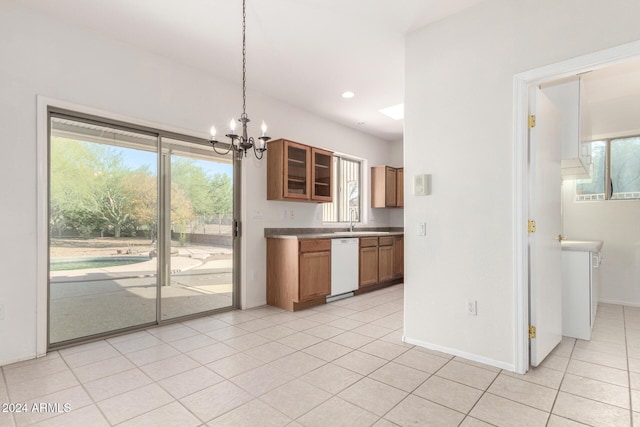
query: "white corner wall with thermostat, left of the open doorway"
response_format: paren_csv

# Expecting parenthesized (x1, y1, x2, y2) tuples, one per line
(404, 0, 640, 369)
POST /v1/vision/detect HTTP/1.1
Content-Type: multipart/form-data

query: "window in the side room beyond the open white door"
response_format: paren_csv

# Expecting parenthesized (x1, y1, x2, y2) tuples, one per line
(576, 136, 640, 201)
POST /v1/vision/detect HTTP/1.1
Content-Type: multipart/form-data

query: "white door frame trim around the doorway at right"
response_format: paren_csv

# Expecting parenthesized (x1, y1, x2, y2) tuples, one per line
(512, 41, 640, 374)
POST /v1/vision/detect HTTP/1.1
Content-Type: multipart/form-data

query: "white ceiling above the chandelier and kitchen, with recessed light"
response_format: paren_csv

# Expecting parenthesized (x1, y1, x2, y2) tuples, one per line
(18, 0, 480, 141)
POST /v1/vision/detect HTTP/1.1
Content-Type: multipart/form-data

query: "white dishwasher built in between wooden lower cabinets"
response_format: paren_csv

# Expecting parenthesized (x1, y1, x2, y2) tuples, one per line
(327, 237, 358, 301)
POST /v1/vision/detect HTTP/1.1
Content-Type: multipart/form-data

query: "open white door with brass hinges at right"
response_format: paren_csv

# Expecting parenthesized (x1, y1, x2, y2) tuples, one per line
(529, 88, 562, 366)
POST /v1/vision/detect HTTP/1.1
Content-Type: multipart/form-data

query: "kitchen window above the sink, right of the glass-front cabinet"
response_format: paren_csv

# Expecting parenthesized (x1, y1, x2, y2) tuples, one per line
(322, 154, 362, 222)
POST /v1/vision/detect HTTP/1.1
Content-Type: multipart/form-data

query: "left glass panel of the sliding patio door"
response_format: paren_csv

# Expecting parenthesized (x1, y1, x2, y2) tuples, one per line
(49, 115, 158, 345)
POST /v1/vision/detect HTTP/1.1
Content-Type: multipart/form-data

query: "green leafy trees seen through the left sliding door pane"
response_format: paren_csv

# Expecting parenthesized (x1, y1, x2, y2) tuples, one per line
(51, 137, 157, 238)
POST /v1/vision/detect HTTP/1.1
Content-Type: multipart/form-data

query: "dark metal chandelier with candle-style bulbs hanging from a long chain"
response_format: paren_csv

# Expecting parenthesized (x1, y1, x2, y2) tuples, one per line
(209, 0, 271, 159)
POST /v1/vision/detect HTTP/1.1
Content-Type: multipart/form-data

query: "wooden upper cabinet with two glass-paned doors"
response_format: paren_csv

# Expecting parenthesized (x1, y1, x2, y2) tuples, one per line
(267, 139, 333, 202)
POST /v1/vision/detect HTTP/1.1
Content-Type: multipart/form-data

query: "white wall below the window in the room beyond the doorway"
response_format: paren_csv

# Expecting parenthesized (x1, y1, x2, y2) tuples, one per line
(562, 180, 640, 306)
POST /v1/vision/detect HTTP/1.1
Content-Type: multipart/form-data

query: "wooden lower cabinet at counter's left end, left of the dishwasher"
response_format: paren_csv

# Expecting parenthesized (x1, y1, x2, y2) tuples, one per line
(267, 238, 331, 311)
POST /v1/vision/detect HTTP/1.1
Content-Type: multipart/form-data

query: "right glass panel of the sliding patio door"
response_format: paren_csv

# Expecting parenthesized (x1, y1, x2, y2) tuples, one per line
(160, 138, 233, 320)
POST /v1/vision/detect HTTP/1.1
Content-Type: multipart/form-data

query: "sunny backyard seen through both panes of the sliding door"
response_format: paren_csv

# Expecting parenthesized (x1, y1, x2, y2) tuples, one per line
(49, 118, 233, 343)
